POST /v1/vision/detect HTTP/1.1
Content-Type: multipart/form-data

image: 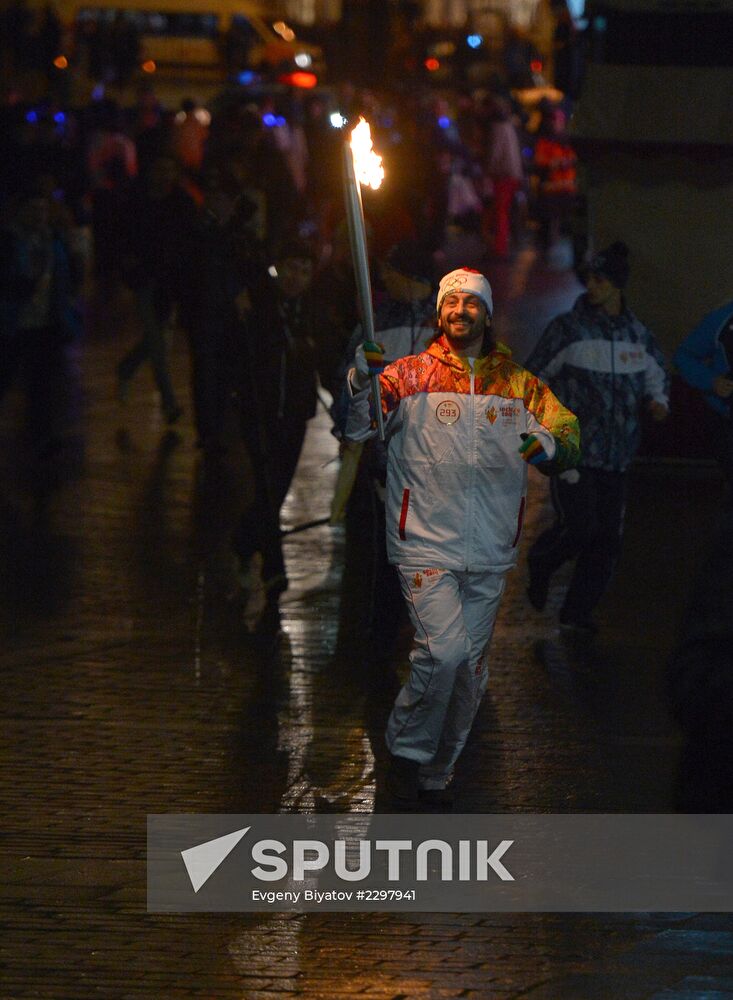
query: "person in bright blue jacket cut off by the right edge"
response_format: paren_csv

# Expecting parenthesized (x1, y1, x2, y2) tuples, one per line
(672, 302, 733, 496)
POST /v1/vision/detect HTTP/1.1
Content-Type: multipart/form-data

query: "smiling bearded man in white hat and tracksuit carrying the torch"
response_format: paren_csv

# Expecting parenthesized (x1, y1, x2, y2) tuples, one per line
(347, 268, 579, 811)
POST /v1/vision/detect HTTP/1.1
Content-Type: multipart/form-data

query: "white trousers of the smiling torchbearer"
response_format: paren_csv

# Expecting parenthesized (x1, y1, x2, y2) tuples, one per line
(386, 566, 505, 788)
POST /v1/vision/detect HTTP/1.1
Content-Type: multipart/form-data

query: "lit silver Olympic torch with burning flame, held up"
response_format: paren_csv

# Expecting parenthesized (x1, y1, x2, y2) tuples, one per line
(344, 118, 384, 441)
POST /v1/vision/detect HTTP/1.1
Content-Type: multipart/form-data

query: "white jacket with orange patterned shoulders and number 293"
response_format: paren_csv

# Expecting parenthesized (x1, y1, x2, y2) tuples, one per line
(346, 337, 579, 573)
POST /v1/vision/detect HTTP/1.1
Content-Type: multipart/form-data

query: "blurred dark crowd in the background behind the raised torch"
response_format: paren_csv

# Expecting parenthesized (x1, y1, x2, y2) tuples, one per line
(0, 69, 577, 446)
